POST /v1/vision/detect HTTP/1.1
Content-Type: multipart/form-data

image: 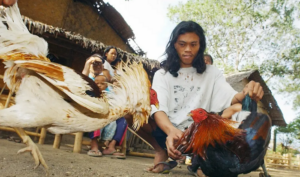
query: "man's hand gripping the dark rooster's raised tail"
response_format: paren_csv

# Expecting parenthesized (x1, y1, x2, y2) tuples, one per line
(243, 81, 264, 101)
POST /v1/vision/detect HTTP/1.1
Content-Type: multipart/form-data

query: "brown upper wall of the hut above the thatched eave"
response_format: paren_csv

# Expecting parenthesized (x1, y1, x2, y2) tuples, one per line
(18, 0, 133, 53)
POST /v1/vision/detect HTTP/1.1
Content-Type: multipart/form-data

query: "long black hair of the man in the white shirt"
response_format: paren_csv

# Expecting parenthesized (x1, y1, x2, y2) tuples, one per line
(161, 21, 206, 77)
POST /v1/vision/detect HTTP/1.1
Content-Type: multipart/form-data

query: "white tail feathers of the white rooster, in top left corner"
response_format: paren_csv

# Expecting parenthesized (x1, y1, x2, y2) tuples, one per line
(0, 3, 48, 60)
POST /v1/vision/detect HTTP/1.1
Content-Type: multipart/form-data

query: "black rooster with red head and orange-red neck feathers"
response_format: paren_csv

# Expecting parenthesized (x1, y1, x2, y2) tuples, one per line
(176, 95, 271, 177)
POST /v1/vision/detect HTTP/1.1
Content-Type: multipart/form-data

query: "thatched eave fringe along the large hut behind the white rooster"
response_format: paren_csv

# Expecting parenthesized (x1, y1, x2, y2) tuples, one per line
(22, 16, 159, 75)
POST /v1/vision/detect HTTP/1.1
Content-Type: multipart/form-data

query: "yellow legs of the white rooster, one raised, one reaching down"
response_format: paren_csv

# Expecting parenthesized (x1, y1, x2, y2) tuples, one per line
(4, 87, 49, 174)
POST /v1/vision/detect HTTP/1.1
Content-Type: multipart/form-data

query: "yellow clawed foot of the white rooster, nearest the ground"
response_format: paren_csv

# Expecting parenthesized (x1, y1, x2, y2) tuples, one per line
(18, 136, 49, 174)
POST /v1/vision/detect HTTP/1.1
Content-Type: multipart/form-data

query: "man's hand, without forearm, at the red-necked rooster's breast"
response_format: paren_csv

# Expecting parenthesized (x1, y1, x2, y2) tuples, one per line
(166, 128, 183, 160)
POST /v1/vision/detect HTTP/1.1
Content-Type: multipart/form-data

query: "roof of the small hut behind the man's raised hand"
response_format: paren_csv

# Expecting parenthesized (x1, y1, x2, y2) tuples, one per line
(226, 70, 286, 126)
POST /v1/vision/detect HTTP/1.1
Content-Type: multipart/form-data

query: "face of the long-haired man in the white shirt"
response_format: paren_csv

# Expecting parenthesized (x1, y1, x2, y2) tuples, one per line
(174, 32, 200, 68)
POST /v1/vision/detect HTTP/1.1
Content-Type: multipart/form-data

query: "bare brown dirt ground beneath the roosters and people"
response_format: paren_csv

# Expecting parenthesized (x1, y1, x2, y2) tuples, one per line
(0, 139, 300, 177)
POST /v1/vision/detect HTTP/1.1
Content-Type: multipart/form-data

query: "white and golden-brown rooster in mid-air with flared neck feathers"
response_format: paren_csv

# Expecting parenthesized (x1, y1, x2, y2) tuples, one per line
(0, 3, 158, 170)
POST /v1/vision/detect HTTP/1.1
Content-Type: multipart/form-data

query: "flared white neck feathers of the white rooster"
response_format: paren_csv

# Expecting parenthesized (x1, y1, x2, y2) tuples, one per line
(107, 62, 151, 129)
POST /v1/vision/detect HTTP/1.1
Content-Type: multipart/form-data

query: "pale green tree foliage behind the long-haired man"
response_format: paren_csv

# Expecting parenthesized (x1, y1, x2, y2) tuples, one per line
(168, 0, 300, 108)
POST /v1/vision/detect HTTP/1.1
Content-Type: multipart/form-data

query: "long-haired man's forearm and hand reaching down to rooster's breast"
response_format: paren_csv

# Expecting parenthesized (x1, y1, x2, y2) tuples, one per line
(154, 111, 182, 159)
